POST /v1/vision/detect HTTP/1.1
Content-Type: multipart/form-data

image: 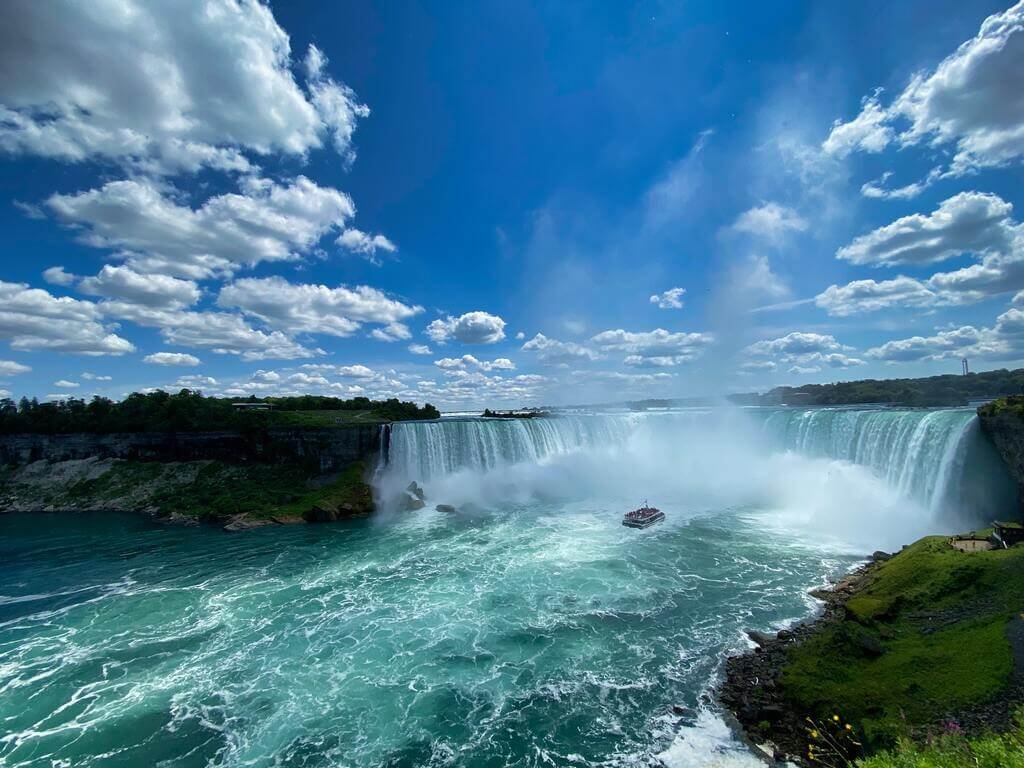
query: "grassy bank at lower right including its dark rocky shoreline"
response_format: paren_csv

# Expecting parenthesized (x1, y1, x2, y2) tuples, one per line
(719, 537, 1024, 764)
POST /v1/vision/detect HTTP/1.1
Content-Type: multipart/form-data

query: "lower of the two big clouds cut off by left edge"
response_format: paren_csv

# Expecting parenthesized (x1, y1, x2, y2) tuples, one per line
(0, 281, 135, 355)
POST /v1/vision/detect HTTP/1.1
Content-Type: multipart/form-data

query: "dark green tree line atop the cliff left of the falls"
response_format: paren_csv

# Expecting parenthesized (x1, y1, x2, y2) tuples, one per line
(0, 389, 440, 434)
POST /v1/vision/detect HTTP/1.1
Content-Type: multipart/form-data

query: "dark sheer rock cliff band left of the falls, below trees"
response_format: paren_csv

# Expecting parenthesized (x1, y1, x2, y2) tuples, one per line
(0, 424, 381, 472)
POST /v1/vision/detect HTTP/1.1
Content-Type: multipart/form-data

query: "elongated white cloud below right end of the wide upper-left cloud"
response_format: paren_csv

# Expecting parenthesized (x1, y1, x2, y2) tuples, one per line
(217, 278, 423, 341)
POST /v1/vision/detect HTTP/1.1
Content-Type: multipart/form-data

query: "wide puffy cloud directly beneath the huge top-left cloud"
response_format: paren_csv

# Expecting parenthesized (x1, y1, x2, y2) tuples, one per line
(46, 176, 355, 279)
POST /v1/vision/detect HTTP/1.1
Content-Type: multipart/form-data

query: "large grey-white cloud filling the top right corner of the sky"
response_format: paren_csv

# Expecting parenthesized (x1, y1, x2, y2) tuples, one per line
(822, 2, 1024, 179)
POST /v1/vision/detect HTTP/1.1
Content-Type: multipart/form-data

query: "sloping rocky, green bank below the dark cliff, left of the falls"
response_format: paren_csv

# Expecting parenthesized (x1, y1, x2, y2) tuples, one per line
(0, 457, 374, 530)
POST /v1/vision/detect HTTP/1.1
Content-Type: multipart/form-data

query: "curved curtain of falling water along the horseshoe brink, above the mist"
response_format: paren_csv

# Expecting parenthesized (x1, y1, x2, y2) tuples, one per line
(384, 408, 1016, 520)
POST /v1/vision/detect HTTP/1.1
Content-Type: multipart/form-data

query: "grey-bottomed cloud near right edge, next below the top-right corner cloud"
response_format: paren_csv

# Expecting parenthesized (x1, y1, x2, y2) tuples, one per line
(836, 191, 1017, 266)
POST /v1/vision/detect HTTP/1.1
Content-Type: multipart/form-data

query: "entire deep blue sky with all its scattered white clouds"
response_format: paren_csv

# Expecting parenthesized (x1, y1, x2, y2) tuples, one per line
(0, 0, 1024, 409)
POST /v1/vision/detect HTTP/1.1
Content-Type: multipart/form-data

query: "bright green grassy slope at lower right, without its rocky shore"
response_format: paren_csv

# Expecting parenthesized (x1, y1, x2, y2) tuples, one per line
(780, 537, 1024, 753)
